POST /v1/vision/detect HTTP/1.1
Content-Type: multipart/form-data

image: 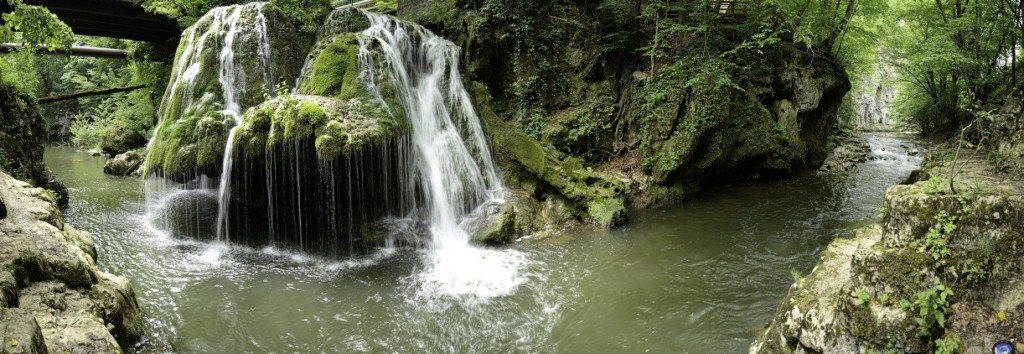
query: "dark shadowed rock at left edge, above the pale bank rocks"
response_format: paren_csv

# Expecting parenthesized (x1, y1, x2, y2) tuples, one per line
(0, 83, 68, 207)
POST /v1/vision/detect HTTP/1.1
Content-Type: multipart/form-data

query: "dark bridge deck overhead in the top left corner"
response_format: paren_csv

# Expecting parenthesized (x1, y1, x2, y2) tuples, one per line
(0, 0, 181, 43)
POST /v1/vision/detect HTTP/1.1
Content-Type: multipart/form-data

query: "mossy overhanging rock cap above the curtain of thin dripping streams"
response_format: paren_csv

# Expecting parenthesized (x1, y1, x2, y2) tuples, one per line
(234, 95, 407, 160)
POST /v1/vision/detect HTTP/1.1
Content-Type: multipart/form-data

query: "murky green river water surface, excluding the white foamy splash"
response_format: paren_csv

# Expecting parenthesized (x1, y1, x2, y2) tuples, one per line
(46, 137, 921, 353)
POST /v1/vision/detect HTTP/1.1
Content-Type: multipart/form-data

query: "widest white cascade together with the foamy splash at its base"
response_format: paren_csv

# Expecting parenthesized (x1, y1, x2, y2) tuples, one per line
(358, 12, 524, 300)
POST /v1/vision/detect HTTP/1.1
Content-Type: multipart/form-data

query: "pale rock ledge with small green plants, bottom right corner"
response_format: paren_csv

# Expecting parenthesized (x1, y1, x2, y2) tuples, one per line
(751, 144, 1024, 353)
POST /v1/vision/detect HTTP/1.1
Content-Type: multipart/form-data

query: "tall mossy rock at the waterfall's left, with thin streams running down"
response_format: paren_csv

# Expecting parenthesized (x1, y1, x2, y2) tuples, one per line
(146, 3, 303, 175)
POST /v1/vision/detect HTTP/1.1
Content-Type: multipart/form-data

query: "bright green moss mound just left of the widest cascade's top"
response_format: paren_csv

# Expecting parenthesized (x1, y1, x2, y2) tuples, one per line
(299, 33, 367, 99)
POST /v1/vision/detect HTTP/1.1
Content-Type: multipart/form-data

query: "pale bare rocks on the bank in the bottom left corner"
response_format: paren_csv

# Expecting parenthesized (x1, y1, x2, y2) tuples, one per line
(0, 172, 142, 353)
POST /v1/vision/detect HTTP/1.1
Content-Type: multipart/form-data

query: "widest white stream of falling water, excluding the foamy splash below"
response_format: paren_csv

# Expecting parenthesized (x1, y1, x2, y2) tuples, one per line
(359, 12, 502, 249)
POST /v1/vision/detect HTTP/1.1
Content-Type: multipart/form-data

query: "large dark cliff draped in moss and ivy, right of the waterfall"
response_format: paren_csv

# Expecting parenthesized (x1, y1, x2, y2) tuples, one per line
(399, 0, 850, 224)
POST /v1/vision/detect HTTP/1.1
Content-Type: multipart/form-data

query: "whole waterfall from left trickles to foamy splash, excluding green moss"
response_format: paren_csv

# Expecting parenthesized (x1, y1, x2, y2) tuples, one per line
(147, 3, 525, 299)
